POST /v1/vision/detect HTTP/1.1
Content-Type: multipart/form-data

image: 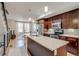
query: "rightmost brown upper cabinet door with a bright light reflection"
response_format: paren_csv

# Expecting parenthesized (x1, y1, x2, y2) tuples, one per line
(70, 10, 78, 29)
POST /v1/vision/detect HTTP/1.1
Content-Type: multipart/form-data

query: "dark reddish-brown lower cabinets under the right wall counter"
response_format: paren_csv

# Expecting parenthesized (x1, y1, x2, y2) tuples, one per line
(59, 36, 79, 55)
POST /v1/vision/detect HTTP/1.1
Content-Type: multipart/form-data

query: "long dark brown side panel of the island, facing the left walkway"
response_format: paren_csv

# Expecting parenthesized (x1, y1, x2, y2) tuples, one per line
(27, 38, 54, 56)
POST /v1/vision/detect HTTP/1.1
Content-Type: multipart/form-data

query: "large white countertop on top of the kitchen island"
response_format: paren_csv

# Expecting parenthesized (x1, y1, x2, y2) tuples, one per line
(27, 35, 68, 51)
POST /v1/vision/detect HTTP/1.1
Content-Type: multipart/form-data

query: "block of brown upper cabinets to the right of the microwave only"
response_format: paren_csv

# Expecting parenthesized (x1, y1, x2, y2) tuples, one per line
(62, 9, 78, 29)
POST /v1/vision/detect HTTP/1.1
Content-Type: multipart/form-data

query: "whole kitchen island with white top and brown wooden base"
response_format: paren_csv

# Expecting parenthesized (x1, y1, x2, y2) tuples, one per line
(27, 35, 68, 56)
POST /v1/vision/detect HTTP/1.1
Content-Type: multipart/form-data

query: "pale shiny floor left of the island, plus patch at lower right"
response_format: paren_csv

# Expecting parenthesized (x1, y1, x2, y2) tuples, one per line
(6, 35, 75, 56)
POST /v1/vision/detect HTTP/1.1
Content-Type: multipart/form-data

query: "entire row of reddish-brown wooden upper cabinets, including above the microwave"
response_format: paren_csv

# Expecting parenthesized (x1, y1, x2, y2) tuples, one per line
(37, 9, 79, 29)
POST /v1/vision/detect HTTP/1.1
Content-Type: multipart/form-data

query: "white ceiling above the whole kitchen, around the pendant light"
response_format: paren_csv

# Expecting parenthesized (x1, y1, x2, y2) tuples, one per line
(5, 2, 79, 21)
